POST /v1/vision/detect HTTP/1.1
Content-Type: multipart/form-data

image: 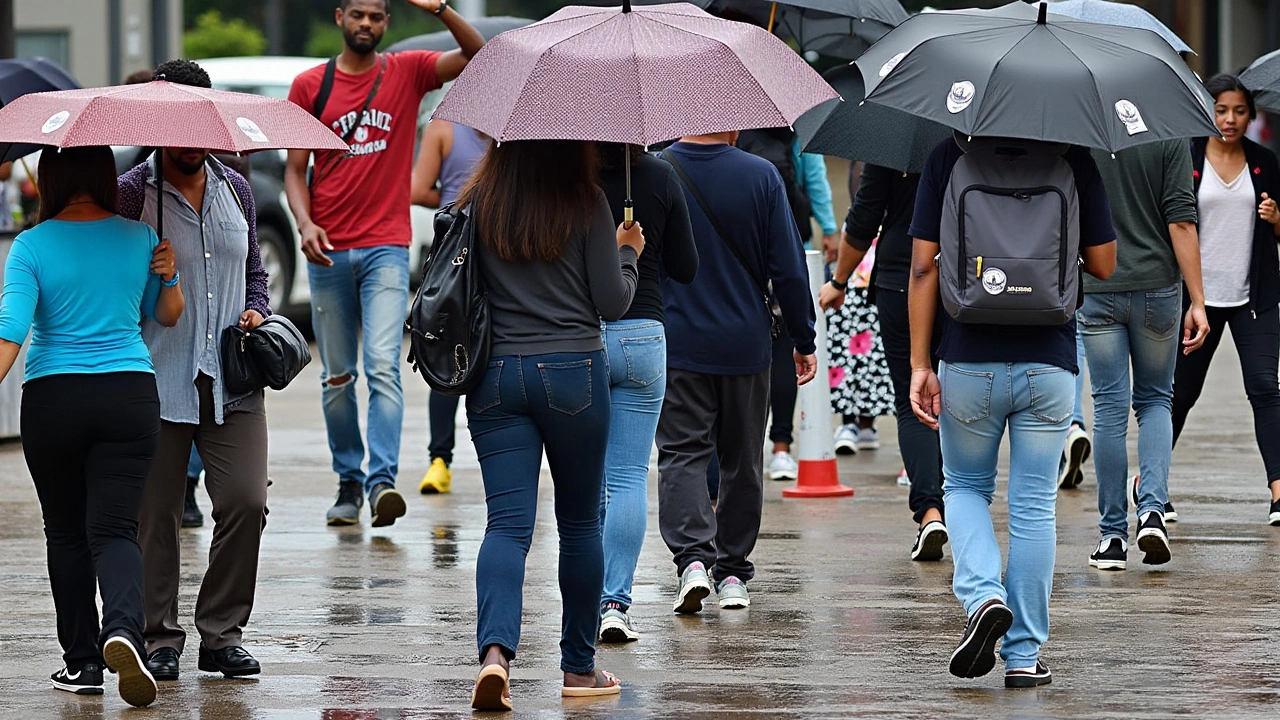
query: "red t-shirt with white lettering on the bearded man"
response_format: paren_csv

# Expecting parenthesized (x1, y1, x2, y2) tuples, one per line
(289, 51, 440, 250)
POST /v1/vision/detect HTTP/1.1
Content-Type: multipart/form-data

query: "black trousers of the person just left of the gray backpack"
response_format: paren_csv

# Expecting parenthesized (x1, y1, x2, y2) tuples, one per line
(876, 288, 943, 523)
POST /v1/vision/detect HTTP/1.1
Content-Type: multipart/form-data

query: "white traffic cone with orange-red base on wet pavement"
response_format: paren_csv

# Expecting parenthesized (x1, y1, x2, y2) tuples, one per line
(782, 250, 854, 497)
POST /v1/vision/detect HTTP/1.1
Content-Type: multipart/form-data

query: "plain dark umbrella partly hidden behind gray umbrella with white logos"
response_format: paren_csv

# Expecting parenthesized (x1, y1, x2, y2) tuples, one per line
(795, 65, 951, 173)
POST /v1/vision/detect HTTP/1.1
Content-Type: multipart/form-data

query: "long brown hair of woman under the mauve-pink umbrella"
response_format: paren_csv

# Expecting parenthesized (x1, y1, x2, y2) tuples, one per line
(458, 140, 600, 263)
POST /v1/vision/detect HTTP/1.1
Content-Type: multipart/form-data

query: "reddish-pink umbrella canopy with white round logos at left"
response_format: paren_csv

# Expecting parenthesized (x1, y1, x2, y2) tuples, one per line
(0, 81, 347, 152)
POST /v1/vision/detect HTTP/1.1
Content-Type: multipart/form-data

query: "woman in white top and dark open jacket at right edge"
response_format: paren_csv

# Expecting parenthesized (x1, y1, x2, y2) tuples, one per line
(1165, 74, 1280, 525)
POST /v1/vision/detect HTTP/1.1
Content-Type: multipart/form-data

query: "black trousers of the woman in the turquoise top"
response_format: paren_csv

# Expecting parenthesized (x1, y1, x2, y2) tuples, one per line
(22, 373, 160, 673)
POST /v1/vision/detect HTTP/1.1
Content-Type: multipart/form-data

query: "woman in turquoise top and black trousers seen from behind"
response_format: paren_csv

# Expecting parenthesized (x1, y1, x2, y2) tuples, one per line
(0, 147, 183, 706)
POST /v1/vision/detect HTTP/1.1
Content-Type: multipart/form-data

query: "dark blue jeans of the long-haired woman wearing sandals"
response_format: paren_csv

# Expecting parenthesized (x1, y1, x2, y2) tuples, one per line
(467, 351, 609, 674)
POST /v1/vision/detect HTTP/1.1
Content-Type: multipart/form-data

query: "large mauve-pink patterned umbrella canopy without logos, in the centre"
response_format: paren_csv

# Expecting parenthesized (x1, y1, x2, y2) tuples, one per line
(435, 3, 836, 146)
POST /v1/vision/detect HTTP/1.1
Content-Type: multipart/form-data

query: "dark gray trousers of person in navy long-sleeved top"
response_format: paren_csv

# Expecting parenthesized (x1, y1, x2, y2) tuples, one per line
(658, 369, 769, 582)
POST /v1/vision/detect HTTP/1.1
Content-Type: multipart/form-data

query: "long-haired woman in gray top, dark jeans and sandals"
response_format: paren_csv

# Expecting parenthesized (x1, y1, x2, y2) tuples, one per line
(458, 141, 644, 710)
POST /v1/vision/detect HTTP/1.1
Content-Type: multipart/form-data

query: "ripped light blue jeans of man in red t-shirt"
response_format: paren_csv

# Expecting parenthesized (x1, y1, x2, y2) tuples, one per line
(307, 246, 408, 489)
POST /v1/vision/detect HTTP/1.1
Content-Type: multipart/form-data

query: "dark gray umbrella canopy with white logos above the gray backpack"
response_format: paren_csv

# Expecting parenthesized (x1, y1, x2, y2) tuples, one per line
(858, 3, 1217, 152)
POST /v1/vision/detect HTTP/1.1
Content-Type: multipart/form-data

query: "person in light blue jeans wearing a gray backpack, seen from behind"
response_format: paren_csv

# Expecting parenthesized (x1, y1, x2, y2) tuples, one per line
(909, 137, 1116, 688)
